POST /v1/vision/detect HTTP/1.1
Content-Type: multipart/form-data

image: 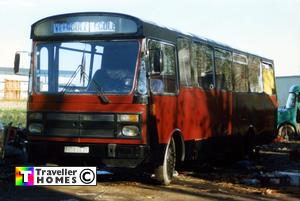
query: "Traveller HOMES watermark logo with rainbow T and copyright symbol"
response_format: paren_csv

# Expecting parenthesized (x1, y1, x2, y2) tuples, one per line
(16, 167, 97, 186)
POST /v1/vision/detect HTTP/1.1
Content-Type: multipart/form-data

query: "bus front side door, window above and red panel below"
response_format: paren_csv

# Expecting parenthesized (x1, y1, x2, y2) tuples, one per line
(148, 40, 178, 144)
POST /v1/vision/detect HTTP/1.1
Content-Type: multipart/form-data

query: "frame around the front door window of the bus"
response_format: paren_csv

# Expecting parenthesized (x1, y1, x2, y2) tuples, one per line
(145, 37, 180, 96)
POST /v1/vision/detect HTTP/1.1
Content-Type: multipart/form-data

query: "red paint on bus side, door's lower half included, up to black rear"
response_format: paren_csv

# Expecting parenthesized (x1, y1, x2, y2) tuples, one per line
(153, 88, 232, 143)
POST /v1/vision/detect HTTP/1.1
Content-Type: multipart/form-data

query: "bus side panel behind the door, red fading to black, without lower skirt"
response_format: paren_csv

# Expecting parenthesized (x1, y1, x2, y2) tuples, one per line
(176, 88, 277, 140)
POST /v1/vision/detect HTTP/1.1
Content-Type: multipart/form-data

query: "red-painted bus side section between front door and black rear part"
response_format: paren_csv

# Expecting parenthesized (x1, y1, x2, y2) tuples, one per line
(177, 88, 232, 140)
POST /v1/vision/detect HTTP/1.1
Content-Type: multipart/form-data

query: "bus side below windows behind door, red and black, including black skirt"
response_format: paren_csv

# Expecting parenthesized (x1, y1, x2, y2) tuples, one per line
(176, 88, 277, 160)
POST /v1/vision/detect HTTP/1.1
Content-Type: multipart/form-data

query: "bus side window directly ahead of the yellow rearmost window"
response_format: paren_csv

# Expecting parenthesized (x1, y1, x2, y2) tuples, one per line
(248, 55, 262, 92)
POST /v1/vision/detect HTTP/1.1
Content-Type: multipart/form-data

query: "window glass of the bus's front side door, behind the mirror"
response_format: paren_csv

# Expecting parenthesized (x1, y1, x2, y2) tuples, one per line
(149, 41, 177, 94)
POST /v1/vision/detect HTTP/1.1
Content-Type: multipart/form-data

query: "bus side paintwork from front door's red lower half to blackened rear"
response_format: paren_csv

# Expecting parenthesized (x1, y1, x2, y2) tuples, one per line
(152, 87, 277, 143)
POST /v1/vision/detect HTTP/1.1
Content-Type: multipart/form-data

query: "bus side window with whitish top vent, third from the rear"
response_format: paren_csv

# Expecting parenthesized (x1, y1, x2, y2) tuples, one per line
(232, 53, 249, 92)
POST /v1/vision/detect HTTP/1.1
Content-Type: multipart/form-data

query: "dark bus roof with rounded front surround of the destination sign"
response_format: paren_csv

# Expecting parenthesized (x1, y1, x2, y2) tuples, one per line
(31, 12, 273, 64)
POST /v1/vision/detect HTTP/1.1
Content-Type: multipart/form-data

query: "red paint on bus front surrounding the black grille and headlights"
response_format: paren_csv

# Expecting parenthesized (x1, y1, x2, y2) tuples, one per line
(28, 95, 147, 144)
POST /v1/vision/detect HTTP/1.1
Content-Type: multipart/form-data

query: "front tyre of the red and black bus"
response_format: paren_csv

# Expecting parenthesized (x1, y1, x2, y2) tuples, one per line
(154, 138, 176, 185)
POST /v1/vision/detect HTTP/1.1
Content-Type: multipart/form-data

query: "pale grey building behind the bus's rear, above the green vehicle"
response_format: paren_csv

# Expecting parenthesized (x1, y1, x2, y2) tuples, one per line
(276, 75, 300, 106)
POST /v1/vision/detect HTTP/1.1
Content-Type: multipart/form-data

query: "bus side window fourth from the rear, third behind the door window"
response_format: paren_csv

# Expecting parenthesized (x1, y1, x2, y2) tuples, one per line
(215, 49, 232, 90)
